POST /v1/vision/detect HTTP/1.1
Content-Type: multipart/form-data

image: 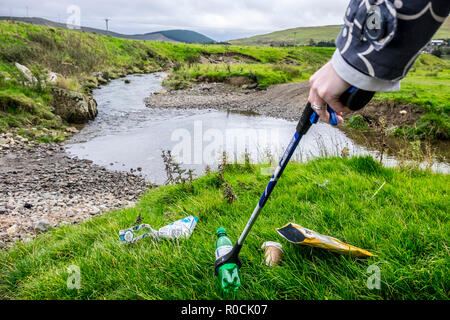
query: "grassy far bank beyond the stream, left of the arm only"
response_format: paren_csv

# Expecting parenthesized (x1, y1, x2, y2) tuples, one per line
(0, 21, 332, 141)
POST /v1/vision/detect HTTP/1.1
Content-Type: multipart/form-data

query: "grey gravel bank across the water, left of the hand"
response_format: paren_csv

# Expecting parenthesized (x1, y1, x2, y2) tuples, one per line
(145, 82, 309, 121)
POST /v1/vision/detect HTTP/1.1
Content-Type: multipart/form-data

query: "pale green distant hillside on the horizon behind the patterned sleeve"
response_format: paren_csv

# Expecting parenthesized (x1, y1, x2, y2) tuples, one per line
(229, 19, 450, 45)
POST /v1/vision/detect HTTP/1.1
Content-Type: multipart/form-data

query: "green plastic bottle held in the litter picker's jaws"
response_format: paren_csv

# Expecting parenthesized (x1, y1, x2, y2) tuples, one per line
(216, 228, 241, 293)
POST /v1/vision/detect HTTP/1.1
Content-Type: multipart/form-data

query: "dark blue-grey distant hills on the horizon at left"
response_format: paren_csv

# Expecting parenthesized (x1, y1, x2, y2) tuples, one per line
(0, 17, 215, 43)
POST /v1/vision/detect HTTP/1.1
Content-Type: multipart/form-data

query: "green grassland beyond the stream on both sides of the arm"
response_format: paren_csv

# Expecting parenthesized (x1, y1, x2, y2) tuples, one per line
(0, 21, 450, 142)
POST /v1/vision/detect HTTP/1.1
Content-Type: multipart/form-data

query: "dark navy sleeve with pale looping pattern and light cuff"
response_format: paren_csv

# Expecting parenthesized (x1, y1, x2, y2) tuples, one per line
(332, 0, 450, 91)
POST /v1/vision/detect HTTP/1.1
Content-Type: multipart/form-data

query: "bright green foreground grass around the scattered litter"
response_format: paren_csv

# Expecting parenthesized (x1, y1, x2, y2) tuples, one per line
(0, 158, 450, 300)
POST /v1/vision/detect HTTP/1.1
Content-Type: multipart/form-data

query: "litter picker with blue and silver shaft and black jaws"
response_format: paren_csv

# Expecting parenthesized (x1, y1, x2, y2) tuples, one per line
(214, 87, 375, 275)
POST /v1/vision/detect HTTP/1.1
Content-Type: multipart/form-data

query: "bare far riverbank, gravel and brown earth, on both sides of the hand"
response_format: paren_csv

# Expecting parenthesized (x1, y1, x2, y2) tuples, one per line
(145, 81, 450, 162)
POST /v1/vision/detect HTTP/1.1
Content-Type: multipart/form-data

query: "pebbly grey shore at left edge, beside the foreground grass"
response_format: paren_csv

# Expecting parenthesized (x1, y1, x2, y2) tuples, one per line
(0, 133, 149, 247)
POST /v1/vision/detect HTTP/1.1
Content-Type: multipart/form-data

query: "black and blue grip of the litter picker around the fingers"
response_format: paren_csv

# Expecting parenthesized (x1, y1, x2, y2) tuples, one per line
(297, 87, 375, 135)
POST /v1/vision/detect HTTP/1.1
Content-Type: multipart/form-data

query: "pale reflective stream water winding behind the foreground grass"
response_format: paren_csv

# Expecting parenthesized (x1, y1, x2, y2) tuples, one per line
(66, 73, 449, 184)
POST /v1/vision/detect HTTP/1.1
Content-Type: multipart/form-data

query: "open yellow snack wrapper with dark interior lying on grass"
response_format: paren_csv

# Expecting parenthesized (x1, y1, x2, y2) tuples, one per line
(277, 223, 374, 258)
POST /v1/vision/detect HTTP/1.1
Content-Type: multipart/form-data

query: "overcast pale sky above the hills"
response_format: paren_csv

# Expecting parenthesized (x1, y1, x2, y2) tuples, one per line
(0, 0, 349, 40)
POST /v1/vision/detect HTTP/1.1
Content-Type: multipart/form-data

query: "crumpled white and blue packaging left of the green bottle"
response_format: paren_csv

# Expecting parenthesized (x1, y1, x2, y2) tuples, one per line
(119, 216, 198, 243)
